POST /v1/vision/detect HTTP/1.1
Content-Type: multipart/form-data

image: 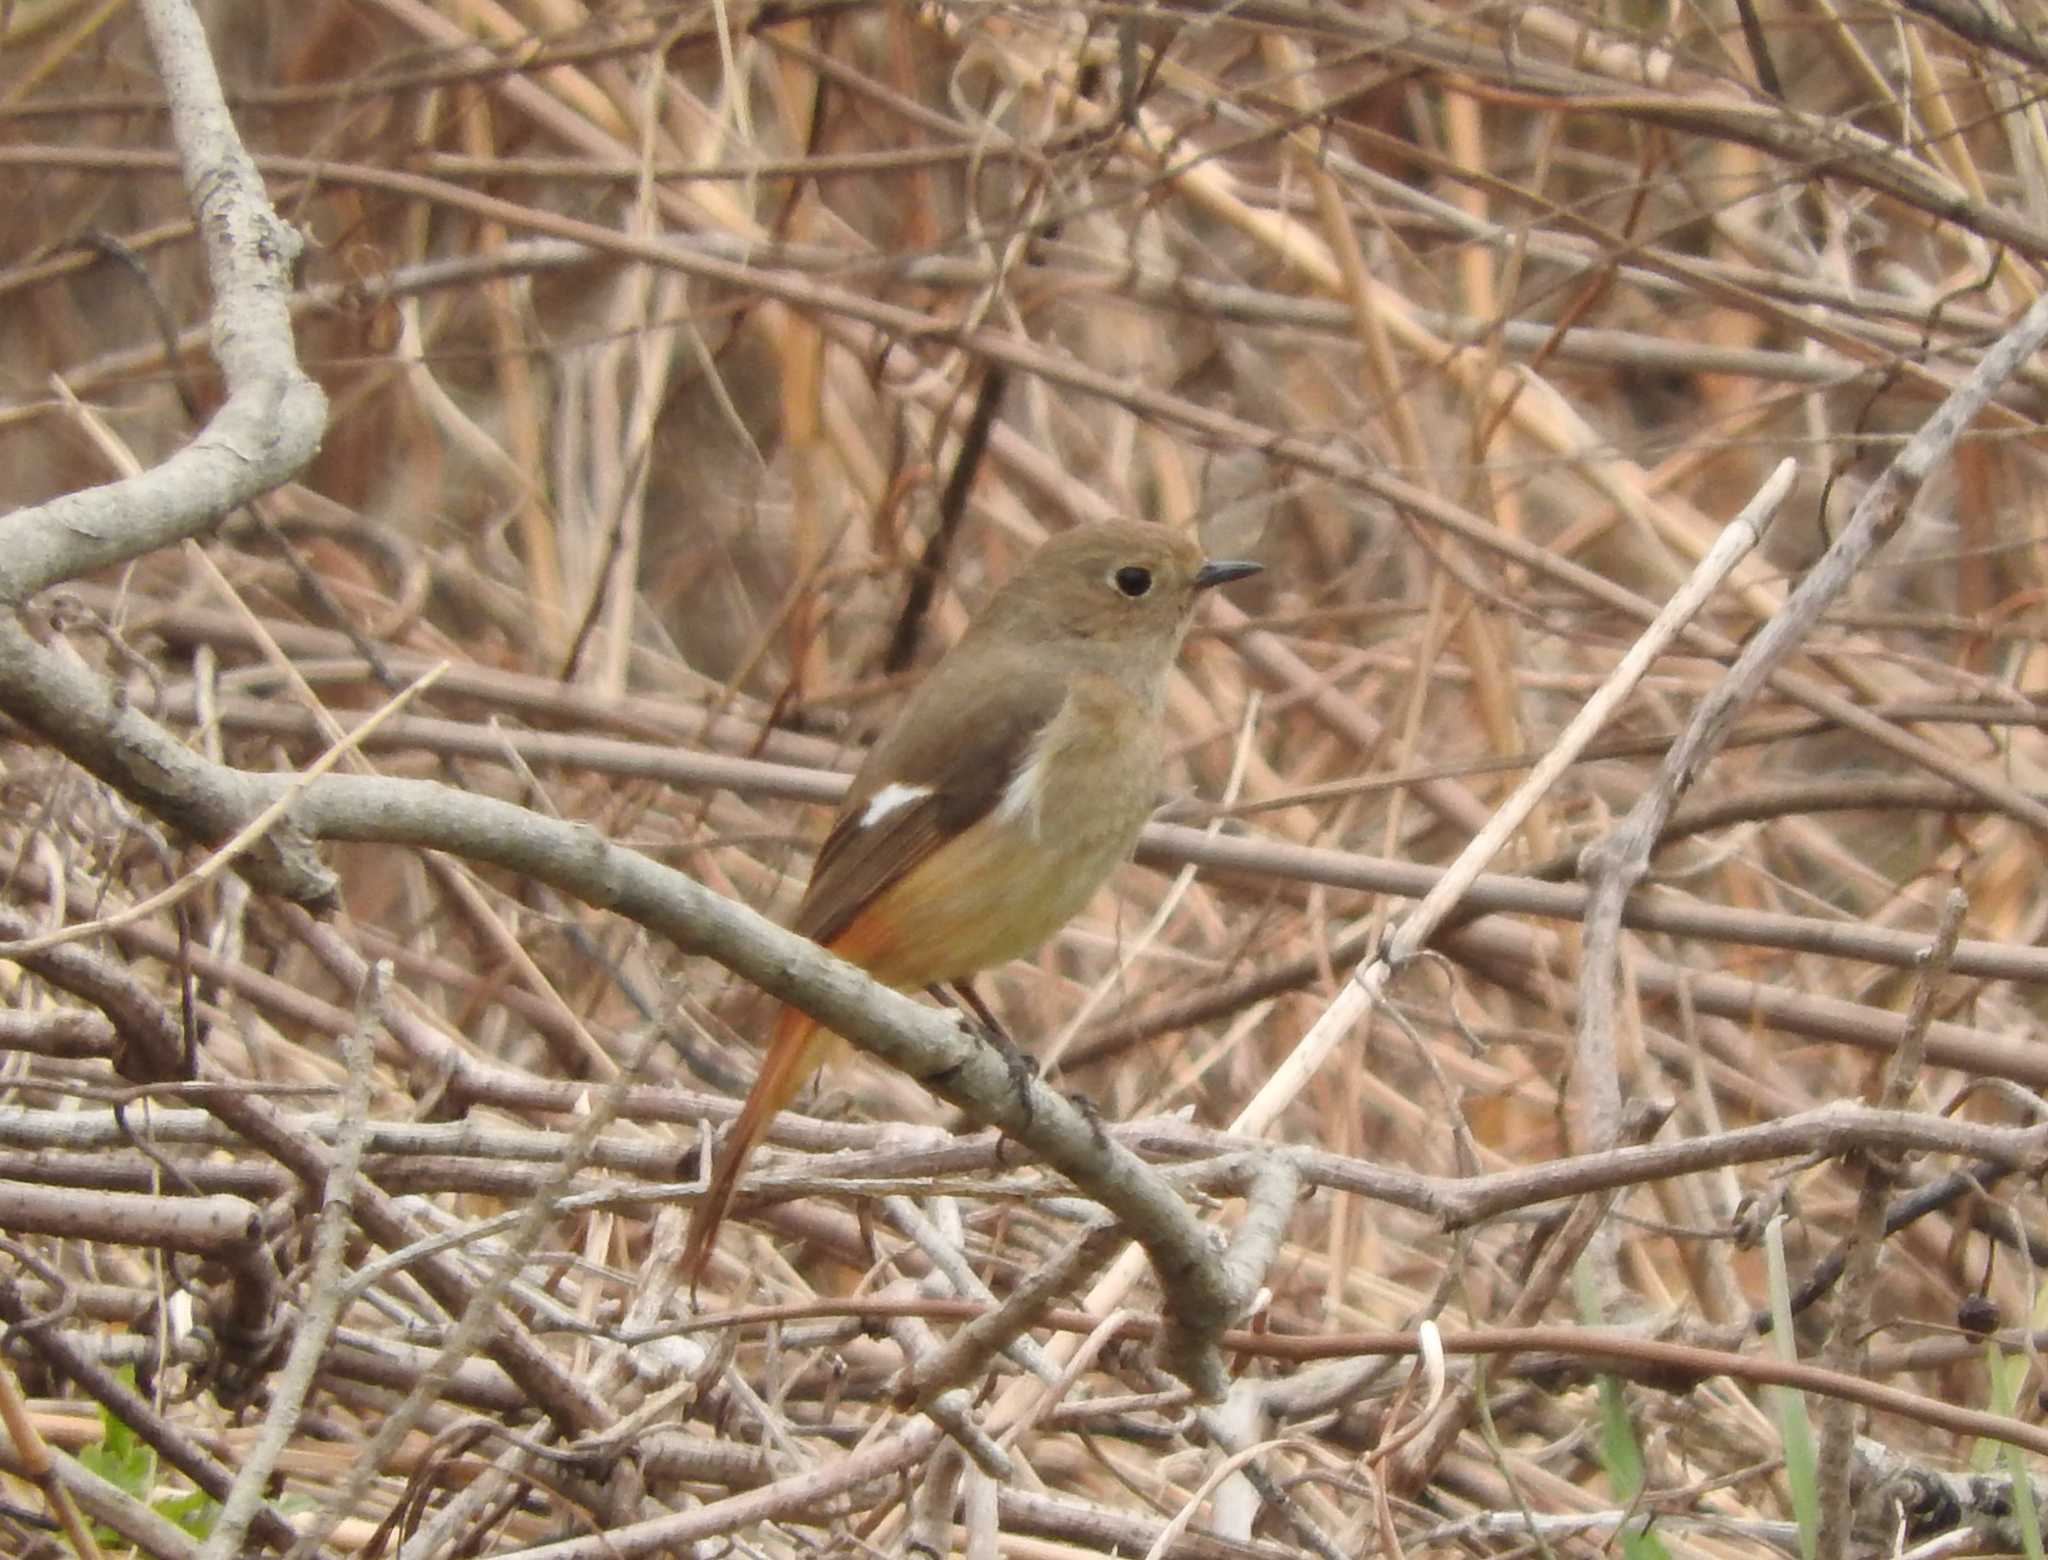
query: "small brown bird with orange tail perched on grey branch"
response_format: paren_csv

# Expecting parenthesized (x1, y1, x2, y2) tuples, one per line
(682, 522, 1260, 1288)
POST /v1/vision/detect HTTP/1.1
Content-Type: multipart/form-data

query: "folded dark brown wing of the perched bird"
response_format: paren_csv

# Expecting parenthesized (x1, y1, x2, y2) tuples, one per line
(795, 663, 1067, 946)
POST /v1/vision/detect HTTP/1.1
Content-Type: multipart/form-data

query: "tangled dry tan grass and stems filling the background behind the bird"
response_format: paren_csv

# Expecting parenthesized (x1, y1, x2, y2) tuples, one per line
(0, 0, 2048, 1556)
